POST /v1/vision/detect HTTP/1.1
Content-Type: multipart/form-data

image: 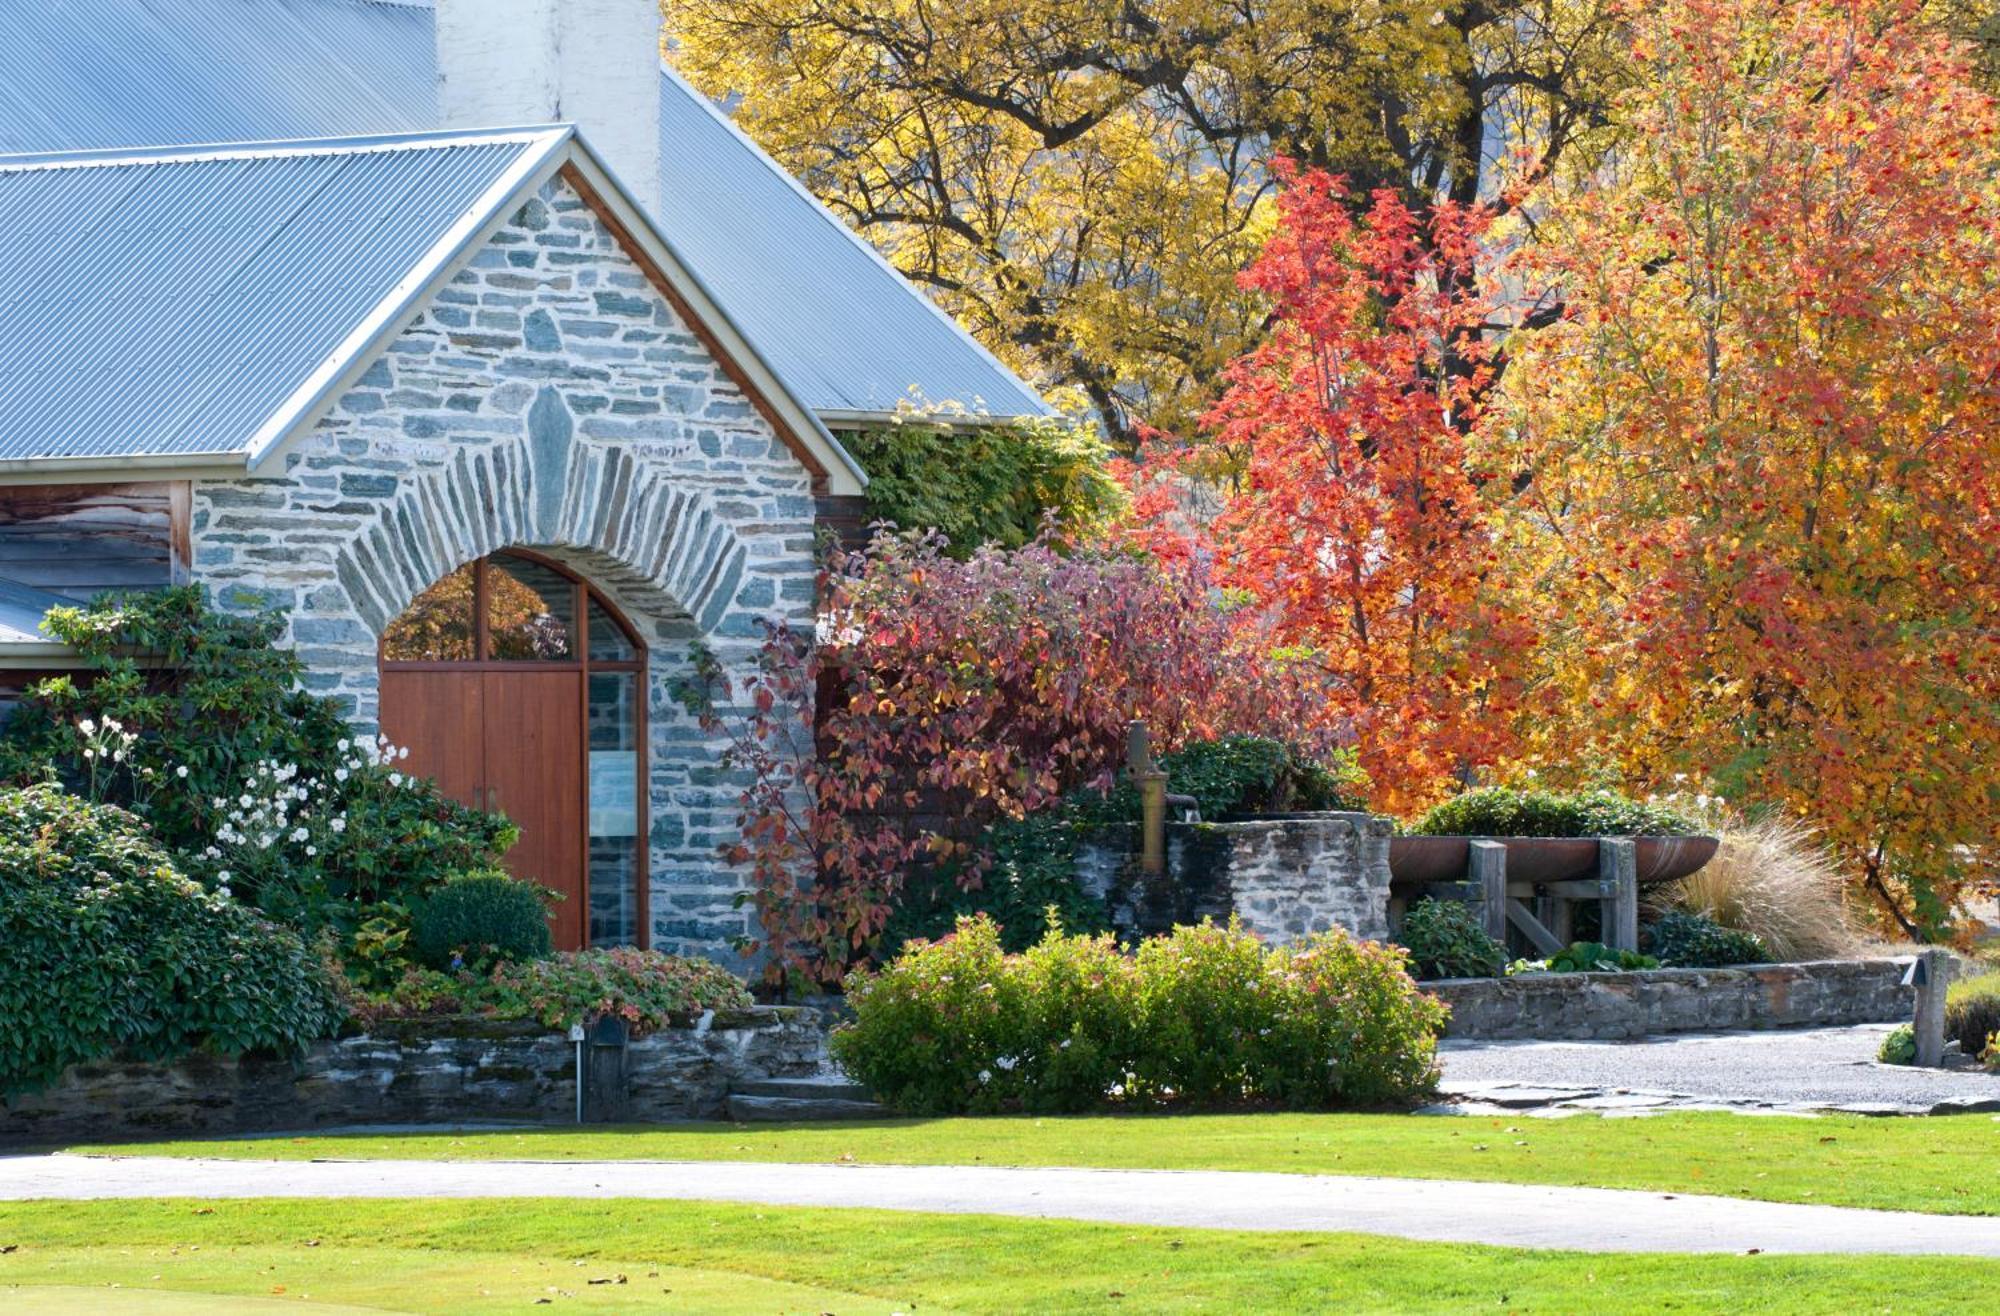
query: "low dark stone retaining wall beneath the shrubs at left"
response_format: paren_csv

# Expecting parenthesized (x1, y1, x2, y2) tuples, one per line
(0, 1006, 826, 1144)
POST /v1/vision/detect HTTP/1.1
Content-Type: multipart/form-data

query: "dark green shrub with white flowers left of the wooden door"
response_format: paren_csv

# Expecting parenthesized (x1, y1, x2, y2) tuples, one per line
(0, 588, 516, 960)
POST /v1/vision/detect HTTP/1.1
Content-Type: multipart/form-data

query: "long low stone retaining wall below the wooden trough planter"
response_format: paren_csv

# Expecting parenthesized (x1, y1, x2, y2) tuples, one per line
(1424, 960, 1916, 1042)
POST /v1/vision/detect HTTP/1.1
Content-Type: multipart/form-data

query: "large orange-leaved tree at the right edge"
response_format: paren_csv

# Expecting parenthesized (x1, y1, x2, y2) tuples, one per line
(1486, 0, 2000, 934)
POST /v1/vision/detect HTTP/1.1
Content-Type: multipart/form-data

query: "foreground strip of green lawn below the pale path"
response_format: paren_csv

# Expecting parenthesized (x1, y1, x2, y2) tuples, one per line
(0, 1200, 2000, 1316)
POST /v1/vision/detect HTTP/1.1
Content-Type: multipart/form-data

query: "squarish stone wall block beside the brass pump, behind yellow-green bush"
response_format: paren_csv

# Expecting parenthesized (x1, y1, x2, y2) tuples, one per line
(1076, 814, 1392, 944)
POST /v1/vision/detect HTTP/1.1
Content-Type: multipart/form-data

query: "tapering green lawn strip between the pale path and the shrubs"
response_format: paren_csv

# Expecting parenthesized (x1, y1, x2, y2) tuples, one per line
(88, 1112, 2000, 1216)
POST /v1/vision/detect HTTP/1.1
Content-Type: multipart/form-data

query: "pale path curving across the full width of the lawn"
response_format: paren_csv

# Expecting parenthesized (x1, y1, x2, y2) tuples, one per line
(0, 1156, 2000, 1258)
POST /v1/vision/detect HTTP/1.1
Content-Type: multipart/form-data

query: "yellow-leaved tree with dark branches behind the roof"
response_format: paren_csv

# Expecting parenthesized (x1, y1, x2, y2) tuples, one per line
(664, 0, 1618, 448)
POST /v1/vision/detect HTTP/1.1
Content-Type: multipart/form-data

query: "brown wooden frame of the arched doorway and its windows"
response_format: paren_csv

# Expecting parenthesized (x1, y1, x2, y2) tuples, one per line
(376, 548, 652, 950)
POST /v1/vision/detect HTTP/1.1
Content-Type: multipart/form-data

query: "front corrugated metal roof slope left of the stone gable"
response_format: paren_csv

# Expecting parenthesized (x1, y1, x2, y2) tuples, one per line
(0, 130, 570, 460)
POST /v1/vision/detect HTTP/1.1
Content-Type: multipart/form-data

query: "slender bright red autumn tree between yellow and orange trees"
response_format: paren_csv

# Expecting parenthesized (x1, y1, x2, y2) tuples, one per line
(1208, 162, 1530, 812)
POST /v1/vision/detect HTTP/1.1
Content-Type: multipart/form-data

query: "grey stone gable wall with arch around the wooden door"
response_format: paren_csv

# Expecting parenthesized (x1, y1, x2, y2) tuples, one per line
(192, 178, 814, 960)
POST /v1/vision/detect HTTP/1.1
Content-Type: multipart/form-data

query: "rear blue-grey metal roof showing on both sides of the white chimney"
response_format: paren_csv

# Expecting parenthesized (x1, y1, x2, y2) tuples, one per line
(0, 0, 1048, 424)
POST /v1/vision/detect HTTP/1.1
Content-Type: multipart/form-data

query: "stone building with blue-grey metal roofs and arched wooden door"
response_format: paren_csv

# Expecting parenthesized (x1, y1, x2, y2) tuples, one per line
(0, 0, 1046, 954)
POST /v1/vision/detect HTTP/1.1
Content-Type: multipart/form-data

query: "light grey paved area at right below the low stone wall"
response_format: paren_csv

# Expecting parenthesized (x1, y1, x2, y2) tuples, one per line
(1438, 1024, 2000, 1114)
